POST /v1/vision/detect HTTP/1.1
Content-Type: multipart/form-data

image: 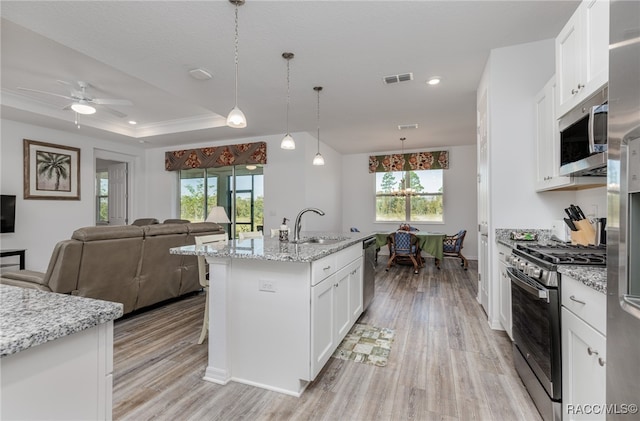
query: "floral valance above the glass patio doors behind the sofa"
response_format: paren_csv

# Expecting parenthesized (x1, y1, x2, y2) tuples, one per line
(164, 142, 267, 171)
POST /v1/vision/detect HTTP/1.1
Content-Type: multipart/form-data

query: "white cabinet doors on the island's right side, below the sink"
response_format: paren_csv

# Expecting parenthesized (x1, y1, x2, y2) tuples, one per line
(311, 245, 363, 379)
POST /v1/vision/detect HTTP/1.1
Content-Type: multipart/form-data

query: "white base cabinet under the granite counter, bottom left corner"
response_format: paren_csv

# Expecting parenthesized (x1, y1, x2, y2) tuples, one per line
(0, 321, 113, 420)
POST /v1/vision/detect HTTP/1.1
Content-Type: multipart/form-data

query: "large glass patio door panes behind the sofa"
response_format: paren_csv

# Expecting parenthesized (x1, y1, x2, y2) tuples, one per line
(179, 165, 264, 237)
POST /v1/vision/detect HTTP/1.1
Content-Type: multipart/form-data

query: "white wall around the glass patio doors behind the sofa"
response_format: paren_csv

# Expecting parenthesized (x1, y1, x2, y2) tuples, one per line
(146, 133, 342, 232)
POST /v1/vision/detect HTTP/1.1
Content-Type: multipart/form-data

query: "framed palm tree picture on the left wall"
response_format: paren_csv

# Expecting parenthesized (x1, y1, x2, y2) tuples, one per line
(23, 139, 80, 200)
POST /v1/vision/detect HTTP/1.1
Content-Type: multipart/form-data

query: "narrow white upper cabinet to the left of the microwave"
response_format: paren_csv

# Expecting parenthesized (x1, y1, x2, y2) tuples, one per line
(534, 76, 604, 192)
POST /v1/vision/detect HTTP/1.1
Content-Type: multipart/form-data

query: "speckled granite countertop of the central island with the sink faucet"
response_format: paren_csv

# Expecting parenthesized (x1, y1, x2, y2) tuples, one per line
(169, 231, 375, 263)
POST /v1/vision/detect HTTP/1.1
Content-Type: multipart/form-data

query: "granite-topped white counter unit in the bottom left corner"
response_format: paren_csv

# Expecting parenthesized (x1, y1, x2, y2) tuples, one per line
(0, 285, 123, 420)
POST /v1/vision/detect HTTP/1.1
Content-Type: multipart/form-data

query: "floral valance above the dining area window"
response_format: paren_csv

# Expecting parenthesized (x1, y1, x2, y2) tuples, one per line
(369, 151, 449, 173)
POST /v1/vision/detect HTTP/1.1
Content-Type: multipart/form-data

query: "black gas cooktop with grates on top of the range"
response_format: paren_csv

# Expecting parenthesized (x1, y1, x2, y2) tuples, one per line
(517, 243, 607, 266)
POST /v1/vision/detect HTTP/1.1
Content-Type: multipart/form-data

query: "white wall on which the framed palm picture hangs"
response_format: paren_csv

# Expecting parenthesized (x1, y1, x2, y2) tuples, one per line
(0, 120, 144, 271)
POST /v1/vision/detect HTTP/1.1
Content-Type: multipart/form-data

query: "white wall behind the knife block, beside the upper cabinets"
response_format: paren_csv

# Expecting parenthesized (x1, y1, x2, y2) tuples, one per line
(485, 39, 576, 230)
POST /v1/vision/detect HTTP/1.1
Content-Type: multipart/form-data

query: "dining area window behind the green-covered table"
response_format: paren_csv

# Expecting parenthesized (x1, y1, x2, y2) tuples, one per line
(375, 170, 444, 222)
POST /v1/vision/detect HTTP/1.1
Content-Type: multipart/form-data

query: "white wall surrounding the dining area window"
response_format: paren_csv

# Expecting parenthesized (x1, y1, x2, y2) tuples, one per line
(342, 145, 478, 259)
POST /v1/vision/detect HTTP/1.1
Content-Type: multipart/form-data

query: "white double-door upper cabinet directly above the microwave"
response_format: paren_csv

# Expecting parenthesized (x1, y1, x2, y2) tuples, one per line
(556, 0, 609, 117)
